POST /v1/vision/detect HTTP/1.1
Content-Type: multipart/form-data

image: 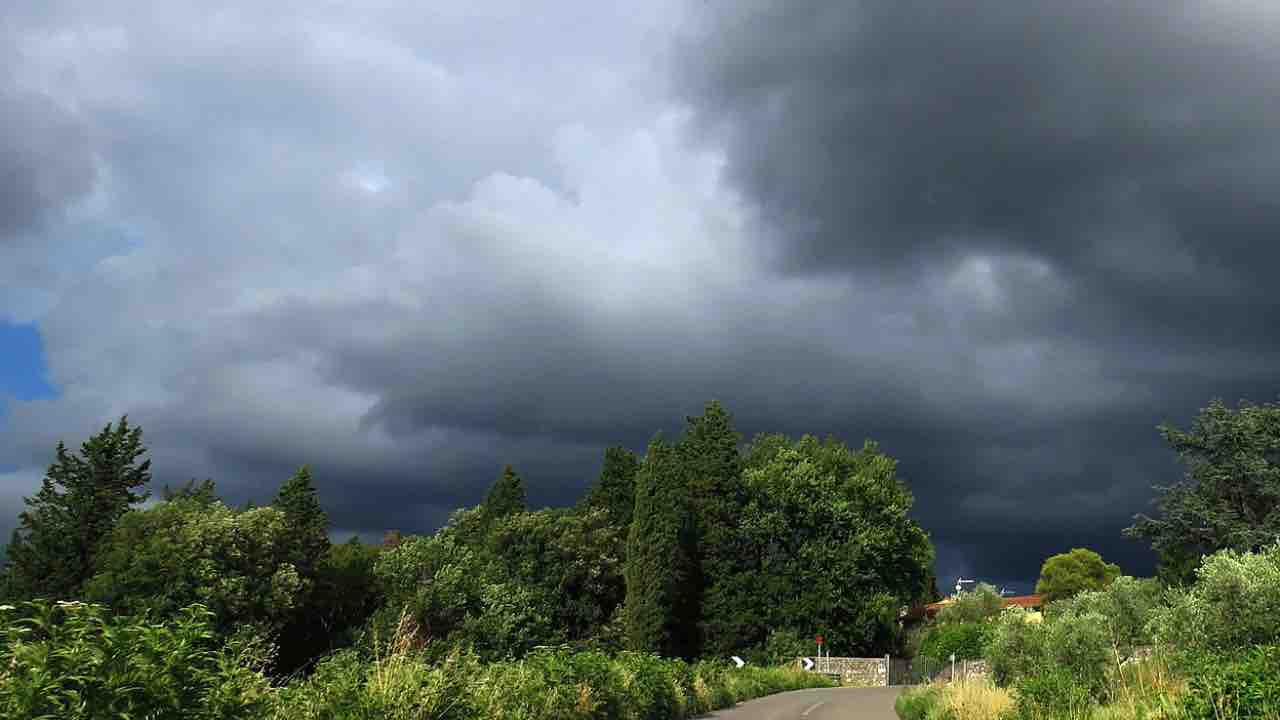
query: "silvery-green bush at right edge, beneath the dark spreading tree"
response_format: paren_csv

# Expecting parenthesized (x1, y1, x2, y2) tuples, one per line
(1148, 543, 1280, 652)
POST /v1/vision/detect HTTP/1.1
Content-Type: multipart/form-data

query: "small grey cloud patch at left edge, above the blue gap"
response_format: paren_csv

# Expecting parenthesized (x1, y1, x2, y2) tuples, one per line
(0, 87, 96, 242)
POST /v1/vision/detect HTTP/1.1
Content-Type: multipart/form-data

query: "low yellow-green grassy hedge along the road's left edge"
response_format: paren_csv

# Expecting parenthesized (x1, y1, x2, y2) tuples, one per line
(274, 638, 829, 720)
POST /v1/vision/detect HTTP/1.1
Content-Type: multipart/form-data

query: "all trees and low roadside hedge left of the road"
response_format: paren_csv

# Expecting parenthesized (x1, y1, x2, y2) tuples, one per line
(0, 402, 901, 720)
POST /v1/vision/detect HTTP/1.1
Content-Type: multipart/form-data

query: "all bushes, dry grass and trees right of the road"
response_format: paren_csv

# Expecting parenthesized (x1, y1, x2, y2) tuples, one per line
(896, 402, 1280, 720)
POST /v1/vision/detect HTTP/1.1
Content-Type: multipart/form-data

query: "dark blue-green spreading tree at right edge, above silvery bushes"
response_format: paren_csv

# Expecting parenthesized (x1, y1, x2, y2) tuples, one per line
(1125, 400, 1280, 583)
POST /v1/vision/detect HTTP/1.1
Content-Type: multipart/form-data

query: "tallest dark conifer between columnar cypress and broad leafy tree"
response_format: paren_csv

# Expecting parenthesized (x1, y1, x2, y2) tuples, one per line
(678, 401, 751, 653)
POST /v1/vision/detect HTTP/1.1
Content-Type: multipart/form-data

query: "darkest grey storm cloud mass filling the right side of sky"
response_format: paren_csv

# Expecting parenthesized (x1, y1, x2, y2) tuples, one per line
(677, 0, 1280, 579)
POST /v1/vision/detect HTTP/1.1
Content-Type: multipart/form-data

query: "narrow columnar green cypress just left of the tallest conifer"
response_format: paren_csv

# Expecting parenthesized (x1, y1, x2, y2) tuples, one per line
(625, 434, 698, 657)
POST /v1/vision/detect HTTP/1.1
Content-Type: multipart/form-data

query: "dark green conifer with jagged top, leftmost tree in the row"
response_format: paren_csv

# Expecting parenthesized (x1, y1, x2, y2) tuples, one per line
(6, 416, 151, 598)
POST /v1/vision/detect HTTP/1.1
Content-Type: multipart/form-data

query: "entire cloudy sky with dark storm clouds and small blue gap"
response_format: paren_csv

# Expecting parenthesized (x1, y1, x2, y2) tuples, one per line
(0, 0, 1280, 589)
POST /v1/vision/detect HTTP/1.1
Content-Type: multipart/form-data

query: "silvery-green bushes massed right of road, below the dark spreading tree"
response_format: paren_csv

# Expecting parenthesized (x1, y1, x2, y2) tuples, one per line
(987, 543, 1280, 720)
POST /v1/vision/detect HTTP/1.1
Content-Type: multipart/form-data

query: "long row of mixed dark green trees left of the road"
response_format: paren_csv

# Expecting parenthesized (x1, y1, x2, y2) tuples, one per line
(0, 402, 934, 676)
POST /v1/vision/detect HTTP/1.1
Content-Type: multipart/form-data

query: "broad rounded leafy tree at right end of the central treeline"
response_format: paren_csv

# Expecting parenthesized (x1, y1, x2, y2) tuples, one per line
(739, 436, 933, 656)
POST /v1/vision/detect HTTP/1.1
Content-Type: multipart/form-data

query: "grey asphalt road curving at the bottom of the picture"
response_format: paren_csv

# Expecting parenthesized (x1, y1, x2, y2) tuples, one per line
(707, 688, 902, 720)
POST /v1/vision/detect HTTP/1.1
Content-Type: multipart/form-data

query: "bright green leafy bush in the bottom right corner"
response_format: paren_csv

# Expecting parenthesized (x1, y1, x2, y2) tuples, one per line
(1183, 646, 1280, 720)
